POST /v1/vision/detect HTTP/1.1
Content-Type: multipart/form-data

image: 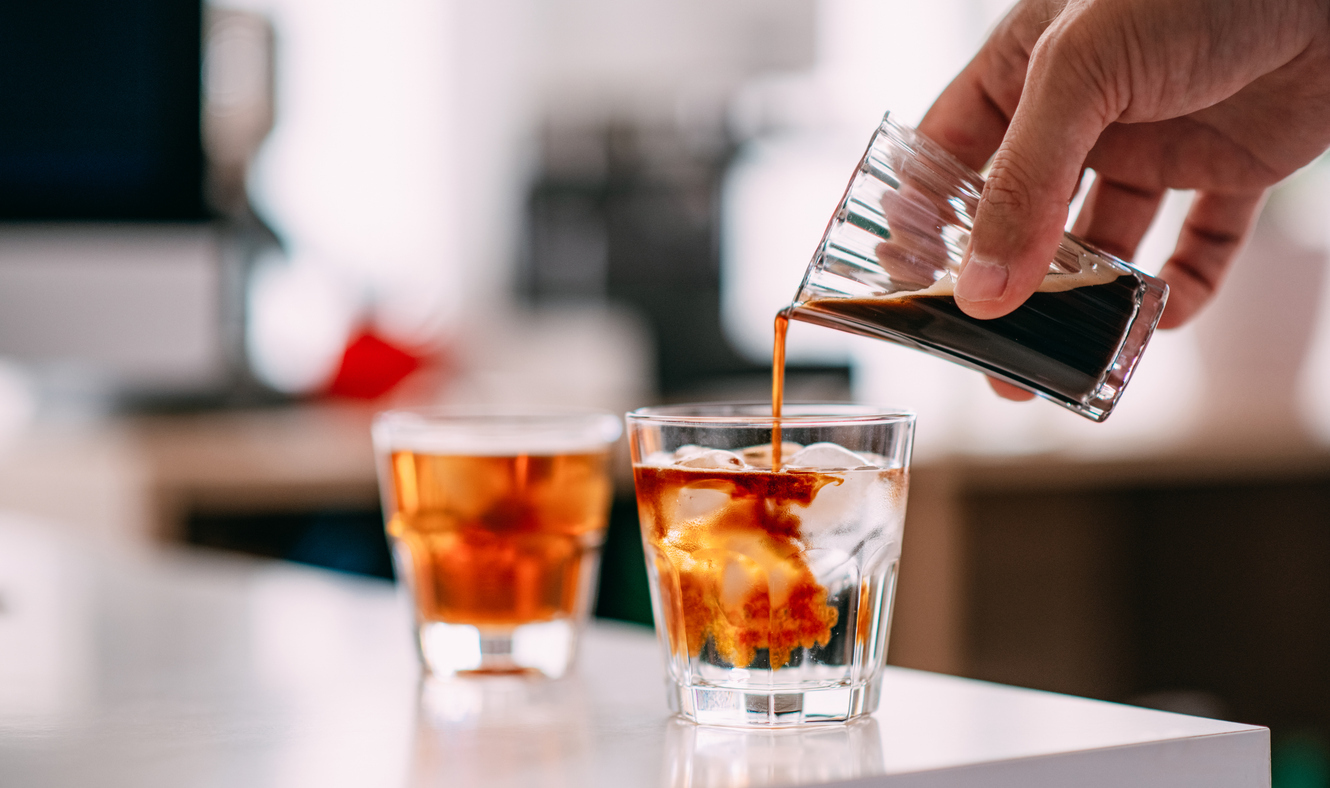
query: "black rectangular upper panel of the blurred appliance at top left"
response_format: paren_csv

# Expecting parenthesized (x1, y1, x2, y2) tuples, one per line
(0, 0, 206, 221)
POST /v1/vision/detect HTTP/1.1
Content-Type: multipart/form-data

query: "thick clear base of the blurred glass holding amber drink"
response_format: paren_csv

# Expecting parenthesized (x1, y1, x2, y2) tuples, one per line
(418, 619, 577, 679)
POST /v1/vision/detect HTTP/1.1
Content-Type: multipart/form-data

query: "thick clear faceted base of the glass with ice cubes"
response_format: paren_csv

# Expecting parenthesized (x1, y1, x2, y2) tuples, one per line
(668, 680, 882, 728)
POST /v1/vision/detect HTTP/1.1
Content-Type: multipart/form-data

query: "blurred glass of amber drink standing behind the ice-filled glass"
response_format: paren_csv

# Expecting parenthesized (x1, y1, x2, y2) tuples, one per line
(372, 410, 621, 678)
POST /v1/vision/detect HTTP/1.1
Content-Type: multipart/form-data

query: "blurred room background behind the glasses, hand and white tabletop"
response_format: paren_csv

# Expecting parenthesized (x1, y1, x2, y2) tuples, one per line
(0, 0, 1330, 788)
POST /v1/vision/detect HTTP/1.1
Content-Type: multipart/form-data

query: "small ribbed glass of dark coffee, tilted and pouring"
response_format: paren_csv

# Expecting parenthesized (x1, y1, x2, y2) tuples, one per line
(789, 113, 1168, 422)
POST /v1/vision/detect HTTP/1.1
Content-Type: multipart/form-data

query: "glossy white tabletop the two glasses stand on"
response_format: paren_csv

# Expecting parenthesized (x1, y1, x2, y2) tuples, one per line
(0, 516, 1270, 788)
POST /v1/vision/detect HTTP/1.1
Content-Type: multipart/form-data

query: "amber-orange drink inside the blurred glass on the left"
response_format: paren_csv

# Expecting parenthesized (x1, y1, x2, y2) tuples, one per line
(387, 451, 610, 626)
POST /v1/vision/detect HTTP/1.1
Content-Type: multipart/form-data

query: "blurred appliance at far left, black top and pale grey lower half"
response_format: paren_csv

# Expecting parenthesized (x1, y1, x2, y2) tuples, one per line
(0, 0, 266, 401)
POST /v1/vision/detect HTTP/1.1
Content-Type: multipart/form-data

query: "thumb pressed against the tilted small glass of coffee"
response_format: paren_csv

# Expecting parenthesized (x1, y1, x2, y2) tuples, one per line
(956, 23, 1119, 318)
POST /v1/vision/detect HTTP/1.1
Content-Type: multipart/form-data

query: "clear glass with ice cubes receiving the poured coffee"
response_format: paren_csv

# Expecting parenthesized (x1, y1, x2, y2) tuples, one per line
(628, 403, 914, 727)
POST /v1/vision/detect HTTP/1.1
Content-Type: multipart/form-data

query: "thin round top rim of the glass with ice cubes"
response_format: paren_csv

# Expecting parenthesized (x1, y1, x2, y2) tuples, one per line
(626, 401, 915, 427)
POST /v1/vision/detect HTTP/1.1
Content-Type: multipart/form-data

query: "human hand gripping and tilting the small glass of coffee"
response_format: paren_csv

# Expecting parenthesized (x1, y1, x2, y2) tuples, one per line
(919, 0, 1330, 397)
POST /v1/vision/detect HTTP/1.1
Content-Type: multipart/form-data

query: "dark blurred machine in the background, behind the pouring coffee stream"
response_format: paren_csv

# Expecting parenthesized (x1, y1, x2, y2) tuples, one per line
(517, 118, 850, 401)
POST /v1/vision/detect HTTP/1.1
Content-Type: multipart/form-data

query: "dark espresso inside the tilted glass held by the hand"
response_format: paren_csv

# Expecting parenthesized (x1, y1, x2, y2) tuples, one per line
(793, 274, 1144, 402)
